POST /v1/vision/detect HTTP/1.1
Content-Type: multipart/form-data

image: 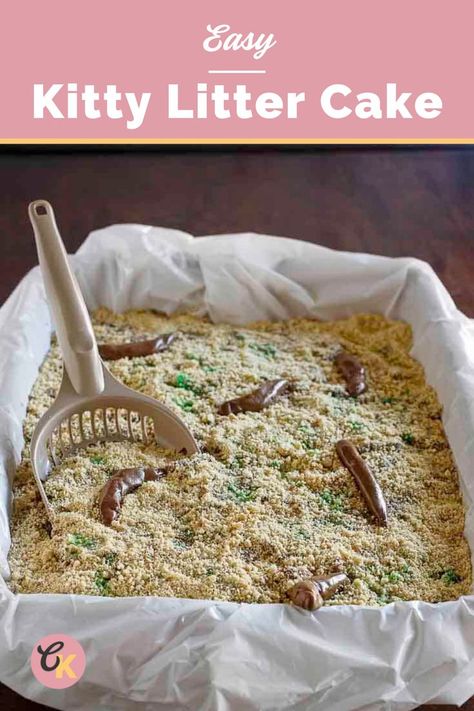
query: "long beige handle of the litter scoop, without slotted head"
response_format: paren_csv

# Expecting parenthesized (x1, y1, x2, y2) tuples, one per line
(28, 200, 104, 395)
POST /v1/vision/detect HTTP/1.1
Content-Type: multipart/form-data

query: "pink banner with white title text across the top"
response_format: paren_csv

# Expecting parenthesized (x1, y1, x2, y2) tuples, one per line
(0, 0, 474, 142)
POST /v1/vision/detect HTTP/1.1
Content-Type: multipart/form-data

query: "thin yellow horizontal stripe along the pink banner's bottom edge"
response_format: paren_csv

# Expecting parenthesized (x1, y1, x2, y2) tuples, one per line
(0, 138, 474, 145)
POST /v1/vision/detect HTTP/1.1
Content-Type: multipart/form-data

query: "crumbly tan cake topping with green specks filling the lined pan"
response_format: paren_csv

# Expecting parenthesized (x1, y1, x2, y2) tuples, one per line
(6, 309, 471, 606)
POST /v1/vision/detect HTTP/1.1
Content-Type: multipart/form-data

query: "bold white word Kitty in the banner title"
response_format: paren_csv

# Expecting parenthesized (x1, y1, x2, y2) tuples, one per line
(33, 83, 151, 129)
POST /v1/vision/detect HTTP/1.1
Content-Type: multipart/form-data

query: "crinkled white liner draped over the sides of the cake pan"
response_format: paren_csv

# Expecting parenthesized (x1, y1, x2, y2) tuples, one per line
(0, 225, 474, 711)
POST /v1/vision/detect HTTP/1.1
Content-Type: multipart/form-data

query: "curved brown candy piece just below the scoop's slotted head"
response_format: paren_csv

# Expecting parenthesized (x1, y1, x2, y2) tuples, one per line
(99, 467, 167, 526)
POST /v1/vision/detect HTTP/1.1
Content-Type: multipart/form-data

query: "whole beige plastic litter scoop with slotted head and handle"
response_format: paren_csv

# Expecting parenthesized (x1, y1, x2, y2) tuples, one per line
(28, 200, 198, 516)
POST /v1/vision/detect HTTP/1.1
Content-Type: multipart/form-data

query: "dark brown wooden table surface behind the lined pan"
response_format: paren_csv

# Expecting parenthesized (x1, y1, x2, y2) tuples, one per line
(0, 147, 474, 711)
